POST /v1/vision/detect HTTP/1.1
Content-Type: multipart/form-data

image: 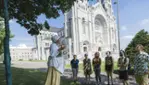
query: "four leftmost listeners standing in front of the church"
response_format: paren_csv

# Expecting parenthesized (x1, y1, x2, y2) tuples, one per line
(71, 51, 114, 85)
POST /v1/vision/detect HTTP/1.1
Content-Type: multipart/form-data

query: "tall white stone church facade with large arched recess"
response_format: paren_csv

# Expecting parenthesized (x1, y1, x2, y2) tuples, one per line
(64, 0, 119, 59)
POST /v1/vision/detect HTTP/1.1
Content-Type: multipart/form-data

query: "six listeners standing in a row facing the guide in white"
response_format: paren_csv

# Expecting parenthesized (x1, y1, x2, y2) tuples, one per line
(71, 44, 149, 85)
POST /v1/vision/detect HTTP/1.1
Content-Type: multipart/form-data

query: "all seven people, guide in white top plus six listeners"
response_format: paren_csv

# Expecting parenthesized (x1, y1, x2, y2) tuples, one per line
(45, 35, 149, 85)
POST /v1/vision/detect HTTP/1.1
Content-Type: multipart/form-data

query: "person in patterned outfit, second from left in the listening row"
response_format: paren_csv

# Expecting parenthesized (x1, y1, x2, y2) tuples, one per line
(83, 54, 92, 84)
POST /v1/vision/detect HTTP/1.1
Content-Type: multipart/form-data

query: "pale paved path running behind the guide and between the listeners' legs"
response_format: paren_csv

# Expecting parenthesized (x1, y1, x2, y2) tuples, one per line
(12, 61, 137, 85)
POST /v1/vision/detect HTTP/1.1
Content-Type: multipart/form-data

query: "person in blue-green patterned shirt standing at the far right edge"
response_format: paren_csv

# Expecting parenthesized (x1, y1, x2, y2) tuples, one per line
(134, 44, 149, 85)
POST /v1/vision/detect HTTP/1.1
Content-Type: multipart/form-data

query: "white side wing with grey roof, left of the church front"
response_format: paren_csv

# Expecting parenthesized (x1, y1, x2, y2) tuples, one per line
(33, 27, 64, 60)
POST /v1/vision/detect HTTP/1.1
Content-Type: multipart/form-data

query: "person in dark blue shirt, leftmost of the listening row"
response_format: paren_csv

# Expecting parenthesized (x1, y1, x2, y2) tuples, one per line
(70, 55, 79, 82)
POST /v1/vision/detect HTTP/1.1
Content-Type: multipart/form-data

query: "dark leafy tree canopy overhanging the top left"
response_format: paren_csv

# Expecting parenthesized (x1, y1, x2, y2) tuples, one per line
(0, 0, 76, 35)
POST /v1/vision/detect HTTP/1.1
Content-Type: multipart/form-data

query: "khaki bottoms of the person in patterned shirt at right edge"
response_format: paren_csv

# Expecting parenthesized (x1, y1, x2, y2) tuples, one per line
(135, 74, 149, 85)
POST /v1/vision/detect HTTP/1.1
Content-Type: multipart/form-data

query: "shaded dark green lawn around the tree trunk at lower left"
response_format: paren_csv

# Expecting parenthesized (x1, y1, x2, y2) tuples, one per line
(0, 64, 71, 85)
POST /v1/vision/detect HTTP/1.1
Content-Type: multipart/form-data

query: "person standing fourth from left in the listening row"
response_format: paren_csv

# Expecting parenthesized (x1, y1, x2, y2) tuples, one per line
(105, 51, 114, 85)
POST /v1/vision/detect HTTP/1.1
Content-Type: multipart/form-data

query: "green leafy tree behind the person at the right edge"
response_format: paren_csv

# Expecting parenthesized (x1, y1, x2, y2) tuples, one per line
(125, 29, 149, 64)
